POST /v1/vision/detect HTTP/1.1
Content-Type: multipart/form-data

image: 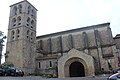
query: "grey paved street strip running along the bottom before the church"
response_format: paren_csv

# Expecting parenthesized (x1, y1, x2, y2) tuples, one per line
(0, 77, 107, 80)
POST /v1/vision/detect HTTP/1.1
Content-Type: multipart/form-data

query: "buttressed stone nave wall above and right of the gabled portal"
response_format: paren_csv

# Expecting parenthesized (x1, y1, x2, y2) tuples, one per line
(37, 23, 116, 75)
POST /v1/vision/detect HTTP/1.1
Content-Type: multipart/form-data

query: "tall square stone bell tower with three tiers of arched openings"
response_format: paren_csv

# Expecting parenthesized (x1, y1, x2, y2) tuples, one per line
(6, 0, 37, 74)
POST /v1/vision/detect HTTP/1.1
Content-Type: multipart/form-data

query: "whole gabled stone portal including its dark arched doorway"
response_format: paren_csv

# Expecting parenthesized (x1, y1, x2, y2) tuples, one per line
(58, 49, 95, 78)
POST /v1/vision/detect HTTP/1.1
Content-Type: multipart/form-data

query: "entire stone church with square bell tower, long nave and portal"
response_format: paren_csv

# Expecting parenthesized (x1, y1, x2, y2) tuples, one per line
(6, 0, 120, 78)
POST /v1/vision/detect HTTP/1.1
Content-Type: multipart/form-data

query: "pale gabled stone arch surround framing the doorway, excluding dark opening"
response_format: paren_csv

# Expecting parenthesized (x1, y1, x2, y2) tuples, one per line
(58, 49, 95, 78)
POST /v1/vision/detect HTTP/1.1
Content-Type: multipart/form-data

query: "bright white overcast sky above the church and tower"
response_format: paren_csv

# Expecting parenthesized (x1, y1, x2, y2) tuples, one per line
(0, 0, 120, 62)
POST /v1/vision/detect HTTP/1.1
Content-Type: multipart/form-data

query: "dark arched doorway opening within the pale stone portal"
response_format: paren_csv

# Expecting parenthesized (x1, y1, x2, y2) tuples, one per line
(69, 61, 85, 77)
